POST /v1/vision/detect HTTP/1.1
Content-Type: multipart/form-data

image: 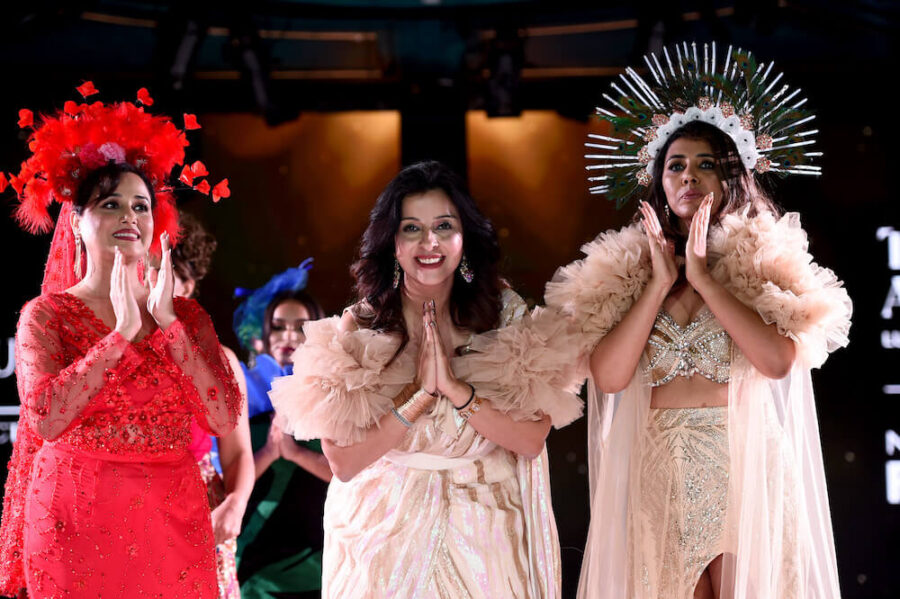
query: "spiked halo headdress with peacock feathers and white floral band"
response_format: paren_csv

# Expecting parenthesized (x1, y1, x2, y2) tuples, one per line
(585, 42, 822, 207)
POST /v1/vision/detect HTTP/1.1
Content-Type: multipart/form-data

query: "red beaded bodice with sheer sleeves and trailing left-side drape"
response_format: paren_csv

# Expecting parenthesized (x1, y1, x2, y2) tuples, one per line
(0, 293, 241, 594)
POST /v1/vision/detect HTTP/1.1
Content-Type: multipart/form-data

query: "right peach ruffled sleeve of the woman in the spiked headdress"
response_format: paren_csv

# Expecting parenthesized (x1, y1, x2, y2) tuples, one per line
(709, 212, 853, 368)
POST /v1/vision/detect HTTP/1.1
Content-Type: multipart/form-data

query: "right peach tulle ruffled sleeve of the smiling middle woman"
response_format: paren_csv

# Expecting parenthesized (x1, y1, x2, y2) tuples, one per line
(453, 308, 584, 428)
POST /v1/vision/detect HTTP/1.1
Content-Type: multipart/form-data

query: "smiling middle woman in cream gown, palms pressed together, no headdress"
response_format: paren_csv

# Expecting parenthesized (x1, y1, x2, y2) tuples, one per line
(270, 162, 581, 599)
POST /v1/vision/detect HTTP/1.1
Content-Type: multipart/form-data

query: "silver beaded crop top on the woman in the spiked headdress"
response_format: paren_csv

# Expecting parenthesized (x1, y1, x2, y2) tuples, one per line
(644, 306, 731, 387)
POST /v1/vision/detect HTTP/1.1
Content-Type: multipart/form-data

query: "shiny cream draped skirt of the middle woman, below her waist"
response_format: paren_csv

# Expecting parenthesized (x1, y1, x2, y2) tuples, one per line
(322, 448, 558, 599)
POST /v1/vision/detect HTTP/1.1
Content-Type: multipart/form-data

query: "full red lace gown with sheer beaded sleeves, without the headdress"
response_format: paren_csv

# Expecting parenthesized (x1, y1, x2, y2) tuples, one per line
(0, 293, 240, 599)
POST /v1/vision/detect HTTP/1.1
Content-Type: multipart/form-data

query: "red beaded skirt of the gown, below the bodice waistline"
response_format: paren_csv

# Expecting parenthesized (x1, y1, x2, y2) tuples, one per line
(24, 443, 216, 599)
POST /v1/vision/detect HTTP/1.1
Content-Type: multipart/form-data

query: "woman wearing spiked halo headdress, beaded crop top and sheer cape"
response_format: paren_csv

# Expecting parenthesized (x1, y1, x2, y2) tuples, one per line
(546, 44, 851, 599)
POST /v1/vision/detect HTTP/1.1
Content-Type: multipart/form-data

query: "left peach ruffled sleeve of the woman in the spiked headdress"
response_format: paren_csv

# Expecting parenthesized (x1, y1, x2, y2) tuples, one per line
(544, 224, 651, 349)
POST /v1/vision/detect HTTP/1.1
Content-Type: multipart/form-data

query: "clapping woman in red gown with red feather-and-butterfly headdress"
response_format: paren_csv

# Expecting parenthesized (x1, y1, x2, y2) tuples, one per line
(0, 86, 240, 599)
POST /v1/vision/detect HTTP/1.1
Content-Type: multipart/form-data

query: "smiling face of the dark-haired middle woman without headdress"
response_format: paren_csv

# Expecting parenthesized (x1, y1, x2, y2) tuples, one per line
(394, 189, 463, 286)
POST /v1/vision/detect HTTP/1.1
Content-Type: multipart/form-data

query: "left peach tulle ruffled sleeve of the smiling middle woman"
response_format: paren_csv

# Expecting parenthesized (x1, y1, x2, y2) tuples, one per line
(269, 317, 415, 446)
